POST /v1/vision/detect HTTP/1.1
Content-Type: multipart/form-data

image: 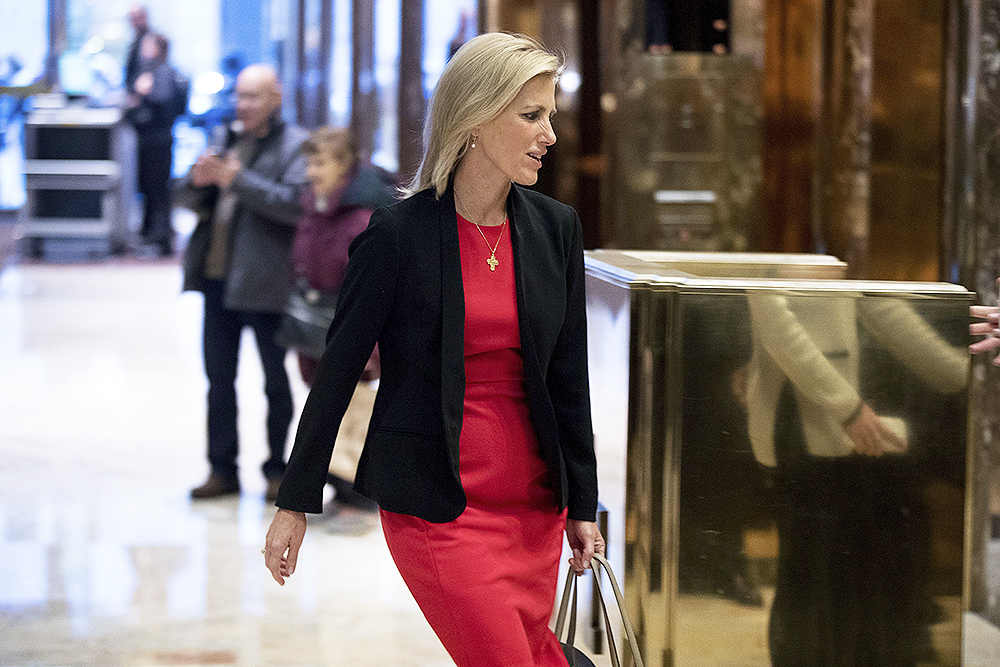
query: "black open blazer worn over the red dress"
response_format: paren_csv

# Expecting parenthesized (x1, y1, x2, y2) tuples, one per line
(276, 185, 597, 523)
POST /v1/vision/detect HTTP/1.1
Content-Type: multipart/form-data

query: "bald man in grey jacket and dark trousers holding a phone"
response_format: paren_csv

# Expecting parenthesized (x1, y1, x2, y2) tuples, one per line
(184, 65, 307, 499)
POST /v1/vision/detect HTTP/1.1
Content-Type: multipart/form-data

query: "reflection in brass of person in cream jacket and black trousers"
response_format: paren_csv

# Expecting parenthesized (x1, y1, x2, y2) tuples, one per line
(746, 293, 968, 667)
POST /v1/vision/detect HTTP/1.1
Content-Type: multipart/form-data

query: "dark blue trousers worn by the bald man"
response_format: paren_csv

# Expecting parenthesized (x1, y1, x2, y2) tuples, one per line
(202, 280, 293, 479)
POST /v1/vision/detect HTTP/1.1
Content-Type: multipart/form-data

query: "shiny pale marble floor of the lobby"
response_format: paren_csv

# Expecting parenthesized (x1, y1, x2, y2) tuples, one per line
(0, 248, 1000, 667)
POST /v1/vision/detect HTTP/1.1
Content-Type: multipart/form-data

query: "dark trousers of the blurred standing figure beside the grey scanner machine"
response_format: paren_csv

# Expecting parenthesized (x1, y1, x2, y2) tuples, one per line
(137, 135, 174, 255)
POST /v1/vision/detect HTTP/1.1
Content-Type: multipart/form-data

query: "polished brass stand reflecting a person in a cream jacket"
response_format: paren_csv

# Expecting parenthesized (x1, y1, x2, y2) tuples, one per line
(587, 251, 972, 667)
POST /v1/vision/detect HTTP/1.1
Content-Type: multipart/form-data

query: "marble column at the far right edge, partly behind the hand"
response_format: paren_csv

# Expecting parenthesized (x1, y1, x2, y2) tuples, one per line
(941, 0, 1000, 624)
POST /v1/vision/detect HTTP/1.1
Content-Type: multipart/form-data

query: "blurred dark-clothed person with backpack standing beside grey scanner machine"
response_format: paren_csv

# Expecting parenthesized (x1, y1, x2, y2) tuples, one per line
(127, 30, 187, 257)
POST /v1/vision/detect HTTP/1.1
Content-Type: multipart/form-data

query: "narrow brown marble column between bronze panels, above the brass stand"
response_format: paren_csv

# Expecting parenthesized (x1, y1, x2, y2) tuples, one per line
(813, 0, 873, 278)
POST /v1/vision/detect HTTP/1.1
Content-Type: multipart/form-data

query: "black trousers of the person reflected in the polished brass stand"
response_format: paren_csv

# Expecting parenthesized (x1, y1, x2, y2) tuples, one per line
(769, 385, 934, 667)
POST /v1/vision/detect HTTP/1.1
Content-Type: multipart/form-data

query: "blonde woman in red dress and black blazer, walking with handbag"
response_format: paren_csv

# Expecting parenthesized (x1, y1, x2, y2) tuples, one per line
(264, 33, 604, 667)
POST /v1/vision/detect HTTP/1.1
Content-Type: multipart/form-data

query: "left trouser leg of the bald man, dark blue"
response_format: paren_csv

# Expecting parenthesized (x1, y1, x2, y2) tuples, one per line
(202, 280, 243, 481)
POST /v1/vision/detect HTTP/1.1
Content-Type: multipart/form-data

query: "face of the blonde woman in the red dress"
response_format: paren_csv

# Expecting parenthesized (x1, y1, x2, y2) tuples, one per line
(469, 74, 556, 185)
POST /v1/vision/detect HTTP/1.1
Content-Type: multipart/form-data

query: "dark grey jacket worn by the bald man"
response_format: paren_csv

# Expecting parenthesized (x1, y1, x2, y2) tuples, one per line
(180, 118, 308, 313)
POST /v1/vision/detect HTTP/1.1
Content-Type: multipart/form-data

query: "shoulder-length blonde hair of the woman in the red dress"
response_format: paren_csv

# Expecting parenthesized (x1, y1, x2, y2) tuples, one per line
(402, 32, 563, 198)
